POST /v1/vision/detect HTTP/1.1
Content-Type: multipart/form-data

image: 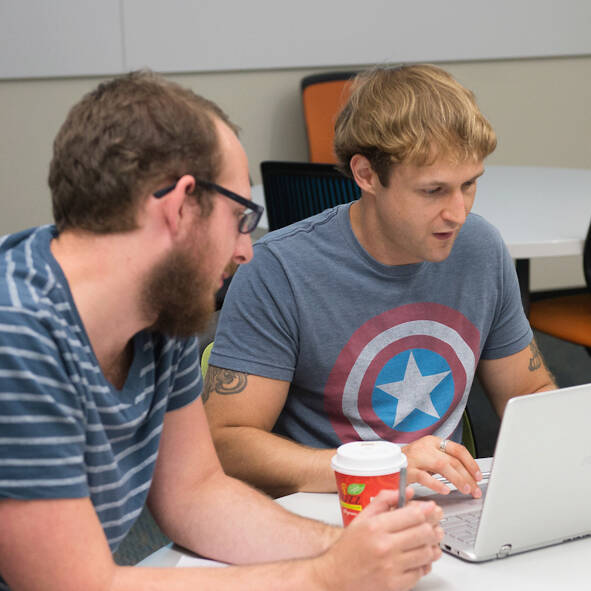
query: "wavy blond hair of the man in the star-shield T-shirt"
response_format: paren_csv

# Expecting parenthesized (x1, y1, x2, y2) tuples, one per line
(334, 64, 497, 186)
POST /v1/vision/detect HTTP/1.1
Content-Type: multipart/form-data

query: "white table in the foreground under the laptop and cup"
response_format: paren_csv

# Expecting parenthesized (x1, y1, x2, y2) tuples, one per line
(138, 458, 591, 591)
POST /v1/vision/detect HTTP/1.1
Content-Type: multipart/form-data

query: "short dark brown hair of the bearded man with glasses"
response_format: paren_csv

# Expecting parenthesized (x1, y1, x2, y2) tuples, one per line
(49, 71, 237, 233)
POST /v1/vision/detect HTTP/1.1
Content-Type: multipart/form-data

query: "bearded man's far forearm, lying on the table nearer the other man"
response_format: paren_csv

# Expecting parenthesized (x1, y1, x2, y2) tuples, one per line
(149, 471, 342, 564)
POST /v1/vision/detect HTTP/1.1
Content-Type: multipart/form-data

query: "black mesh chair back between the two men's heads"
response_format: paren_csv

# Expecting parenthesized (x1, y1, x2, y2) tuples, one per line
(261, 160, 361, 230)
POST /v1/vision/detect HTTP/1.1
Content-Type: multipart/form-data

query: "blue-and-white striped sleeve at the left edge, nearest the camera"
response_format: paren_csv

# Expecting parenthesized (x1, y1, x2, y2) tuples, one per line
(0, 309, 89, 499)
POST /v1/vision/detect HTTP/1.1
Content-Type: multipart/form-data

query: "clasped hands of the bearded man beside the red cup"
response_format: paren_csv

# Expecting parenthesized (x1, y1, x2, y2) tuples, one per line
(316, 490, 443, 591)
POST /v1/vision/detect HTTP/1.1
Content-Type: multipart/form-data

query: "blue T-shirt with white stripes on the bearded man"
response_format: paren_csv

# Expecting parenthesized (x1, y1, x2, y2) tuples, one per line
(0, 226, 202, 590)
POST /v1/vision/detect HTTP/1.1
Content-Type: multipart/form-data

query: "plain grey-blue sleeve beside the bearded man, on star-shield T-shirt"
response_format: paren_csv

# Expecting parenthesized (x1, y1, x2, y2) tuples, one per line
(209, 244, 299, 381)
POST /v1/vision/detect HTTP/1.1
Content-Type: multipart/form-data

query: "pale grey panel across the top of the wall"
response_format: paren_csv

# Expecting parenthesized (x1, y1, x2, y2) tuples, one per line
(0, 0, 591, 78)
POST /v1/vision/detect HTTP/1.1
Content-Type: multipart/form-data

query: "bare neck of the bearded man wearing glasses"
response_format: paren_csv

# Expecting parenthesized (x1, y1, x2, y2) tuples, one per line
(51, 231, 155, 388)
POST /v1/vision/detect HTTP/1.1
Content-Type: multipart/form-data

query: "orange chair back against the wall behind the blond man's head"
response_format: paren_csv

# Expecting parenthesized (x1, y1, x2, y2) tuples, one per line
(301, 72, 357, 164)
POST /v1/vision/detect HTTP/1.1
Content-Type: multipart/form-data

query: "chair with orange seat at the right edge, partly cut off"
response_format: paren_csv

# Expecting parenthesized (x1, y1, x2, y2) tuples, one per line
(529, 220, 591, 355)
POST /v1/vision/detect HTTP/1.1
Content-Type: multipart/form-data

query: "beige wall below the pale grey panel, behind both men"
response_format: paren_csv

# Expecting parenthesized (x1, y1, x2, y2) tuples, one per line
(0, 56, 591, 289)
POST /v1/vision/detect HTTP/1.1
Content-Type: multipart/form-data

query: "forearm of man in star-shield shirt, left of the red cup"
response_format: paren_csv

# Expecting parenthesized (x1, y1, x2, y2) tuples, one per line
(214, 427, 336, 497)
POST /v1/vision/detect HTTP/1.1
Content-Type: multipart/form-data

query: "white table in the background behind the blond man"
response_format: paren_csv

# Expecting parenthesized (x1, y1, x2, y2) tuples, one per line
(252, 166, 591, 310)
